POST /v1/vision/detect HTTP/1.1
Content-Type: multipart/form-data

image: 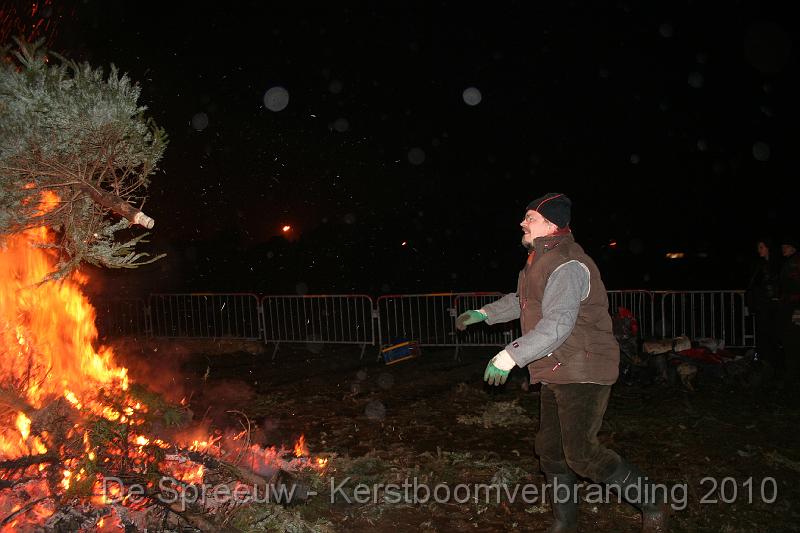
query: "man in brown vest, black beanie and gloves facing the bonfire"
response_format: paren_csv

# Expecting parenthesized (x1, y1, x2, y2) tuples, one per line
(456, 193, 669, 532)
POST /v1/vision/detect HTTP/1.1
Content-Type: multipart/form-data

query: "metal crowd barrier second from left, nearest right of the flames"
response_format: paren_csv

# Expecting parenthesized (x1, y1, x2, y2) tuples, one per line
(149, 293, 262, 340)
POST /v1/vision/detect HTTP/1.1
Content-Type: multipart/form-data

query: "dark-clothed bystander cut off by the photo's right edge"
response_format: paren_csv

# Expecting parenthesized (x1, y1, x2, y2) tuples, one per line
(779, 237, 800, 382)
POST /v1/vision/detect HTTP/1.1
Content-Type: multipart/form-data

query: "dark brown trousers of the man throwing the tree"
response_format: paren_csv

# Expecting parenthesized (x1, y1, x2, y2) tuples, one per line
(536, 383, 622, 482)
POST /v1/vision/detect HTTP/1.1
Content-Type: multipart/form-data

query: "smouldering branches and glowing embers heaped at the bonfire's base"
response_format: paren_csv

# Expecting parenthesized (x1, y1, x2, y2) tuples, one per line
(0, 387, 325, 531)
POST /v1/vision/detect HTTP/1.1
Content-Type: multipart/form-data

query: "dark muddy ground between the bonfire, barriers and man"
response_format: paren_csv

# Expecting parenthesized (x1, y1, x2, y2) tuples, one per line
(109, 339, 800, 532)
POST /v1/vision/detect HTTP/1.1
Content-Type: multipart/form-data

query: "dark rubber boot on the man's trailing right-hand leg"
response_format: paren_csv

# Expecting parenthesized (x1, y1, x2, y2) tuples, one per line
(604, 459, 670, 533)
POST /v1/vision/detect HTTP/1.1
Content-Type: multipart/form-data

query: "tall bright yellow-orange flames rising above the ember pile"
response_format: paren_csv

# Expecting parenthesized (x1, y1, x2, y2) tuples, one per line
(0, 191, 128, 416)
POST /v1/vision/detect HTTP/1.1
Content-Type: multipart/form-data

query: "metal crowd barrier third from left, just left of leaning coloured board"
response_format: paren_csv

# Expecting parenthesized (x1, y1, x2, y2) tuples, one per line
(261, 294, 375, 358)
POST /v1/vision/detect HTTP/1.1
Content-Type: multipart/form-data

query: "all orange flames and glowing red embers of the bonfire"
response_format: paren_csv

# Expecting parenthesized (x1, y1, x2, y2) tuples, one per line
(0, 191, 325, 531)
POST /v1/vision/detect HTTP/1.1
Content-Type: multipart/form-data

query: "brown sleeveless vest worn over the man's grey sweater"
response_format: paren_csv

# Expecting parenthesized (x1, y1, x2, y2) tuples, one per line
(517, 233, 619, 385)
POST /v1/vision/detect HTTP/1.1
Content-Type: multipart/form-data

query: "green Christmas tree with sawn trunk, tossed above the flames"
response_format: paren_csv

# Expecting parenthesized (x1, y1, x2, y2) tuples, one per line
(0, 40, 167, 279)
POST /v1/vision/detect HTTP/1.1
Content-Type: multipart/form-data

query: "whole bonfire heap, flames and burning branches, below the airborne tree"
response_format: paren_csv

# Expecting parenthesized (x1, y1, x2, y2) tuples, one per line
(0, 215, 325, 531)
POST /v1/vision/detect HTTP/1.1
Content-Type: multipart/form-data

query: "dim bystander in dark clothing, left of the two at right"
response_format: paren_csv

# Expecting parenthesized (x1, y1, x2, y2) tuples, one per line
(746, 239, 784, 373)
